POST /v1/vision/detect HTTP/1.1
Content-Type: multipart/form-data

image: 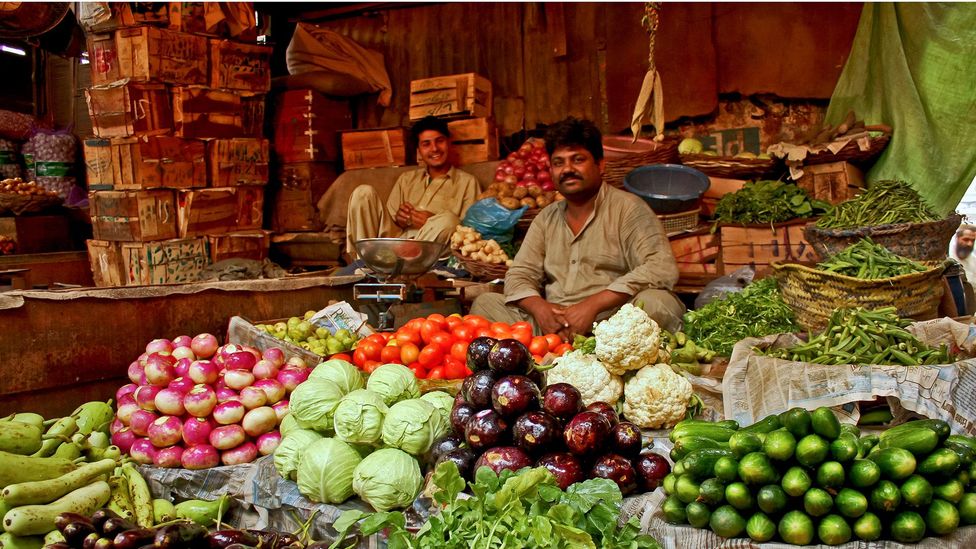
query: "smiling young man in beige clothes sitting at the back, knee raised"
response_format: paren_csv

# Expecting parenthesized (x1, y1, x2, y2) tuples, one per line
(346, 116, 480, 258)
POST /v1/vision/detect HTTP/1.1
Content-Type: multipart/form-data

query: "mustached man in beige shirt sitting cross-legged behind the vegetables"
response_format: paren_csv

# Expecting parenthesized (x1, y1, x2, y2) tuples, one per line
(471, 117, 684, 338)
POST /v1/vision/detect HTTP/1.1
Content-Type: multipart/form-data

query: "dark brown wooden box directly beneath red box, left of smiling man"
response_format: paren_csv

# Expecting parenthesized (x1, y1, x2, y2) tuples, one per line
(271, 162, 338, 233)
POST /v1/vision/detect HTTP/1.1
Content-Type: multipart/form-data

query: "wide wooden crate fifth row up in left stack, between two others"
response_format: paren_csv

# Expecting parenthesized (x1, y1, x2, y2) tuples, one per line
(115, 27, 208, 86)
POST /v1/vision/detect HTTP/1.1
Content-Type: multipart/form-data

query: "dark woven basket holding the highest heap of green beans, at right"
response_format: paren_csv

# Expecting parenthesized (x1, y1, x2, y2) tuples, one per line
(803, 214, 962, 261)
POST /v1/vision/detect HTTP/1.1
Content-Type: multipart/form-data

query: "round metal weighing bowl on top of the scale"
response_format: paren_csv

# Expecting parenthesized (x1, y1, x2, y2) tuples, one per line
(354, 238, 447, 279)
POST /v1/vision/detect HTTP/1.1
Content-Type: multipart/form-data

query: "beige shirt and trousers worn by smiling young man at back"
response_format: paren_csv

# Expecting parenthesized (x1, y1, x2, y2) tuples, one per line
(346, 168, 480, 257)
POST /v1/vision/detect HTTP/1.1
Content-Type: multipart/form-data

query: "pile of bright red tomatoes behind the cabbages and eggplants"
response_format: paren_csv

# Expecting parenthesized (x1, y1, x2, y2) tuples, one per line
(340, 314, 573, 379)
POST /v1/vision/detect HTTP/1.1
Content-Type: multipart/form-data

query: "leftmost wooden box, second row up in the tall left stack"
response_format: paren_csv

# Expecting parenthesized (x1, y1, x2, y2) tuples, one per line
(89, 189, 177, 242)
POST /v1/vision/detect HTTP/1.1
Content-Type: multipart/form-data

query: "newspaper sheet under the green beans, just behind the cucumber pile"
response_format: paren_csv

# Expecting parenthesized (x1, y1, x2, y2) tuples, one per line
(722, 318, 976, 435)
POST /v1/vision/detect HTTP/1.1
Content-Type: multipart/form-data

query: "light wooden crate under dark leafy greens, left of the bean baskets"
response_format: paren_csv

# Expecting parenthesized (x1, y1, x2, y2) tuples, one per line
(719, 219, 816, 273)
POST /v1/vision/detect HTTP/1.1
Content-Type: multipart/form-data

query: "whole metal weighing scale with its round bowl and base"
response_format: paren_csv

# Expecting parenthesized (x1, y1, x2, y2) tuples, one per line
(352, 238, 447, 332)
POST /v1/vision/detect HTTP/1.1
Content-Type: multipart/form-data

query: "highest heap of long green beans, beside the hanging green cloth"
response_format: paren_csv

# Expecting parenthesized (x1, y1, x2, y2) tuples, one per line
(817, 180, 939, 229)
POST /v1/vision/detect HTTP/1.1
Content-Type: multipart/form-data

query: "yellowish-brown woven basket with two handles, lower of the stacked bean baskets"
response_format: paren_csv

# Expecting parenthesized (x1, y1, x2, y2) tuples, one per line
(772, 263, 945, 331)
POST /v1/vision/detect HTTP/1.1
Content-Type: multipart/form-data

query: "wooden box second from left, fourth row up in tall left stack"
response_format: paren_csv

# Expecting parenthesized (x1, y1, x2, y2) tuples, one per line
(172, 86, 245, 139)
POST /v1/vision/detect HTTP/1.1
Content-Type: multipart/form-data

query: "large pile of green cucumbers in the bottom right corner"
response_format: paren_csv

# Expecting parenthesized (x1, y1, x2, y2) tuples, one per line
(662, 408, 976, 545)
